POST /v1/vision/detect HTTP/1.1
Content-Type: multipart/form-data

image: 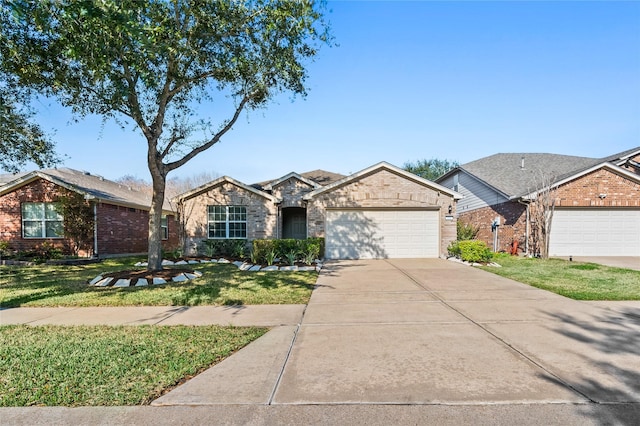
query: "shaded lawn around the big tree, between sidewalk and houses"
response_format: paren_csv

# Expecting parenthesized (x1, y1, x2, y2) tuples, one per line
(0, 258, 317, 308)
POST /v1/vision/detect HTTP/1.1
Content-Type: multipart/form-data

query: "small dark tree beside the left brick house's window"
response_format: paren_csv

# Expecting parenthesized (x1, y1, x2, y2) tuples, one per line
(56, 191, 95, 256)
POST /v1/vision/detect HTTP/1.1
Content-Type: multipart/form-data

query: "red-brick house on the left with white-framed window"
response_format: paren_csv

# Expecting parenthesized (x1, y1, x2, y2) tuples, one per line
(0, 168, 178, 256)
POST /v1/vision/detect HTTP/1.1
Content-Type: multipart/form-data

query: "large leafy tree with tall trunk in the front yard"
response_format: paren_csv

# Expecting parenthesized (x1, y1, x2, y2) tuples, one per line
(0, 0, 328, 270)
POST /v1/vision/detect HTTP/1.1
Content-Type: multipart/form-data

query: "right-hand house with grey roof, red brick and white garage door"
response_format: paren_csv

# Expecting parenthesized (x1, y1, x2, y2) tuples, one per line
(436, 147, 640, 256)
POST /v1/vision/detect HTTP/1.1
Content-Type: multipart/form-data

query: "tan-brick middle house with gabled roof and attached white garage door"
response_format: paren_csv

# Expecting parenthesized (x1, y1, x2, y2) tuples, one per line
(175, 163, 460, 259)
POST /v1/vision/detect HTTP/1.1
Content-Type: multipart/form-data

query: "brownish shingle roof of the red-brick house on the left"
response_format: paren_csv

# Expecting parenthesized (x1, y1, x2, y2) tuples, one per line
(0, 168, 171, 212)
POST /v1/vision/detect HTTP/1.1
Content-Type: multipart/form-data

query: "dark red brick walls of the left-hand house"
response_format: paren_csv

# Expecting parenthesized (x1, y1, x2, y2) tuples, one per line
(0, 179, 178, 256)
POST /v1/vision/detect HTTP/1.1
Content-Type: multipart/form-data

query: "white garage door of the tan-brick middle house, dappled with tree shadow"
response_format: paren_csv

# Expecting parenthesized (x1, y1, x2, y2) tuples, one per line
(325, 210, 440, 259)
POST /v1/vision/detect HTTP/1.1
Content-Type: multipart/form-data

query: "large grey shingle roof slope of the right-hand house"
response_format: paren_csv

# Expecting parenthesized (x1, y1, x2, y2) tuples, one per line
(459, 153, 603, 197)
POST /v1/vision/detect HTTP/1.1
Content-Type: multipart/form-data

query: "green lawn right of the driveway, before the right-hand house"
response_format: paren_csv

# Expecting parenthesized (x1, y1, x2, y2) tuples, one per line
(482, 256, 640, 300)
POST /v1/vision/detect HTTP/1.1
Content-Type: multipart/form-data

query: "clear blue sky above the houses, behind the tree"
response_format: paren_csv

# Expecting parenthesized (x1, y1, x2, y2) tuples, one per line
(28, 1, 640, 183)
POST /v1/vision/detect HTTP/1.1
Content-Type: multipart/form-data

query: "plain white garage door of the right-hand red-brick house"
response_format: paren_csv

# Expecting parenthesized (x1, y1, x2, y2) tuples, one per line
(549, 209, 640, 256)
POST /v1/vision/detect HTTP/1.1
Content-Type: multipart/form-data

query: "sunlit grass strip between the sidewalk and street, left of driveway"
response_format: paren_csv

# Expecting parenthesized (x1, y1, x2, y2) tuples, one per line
(0, 325, 266, 407)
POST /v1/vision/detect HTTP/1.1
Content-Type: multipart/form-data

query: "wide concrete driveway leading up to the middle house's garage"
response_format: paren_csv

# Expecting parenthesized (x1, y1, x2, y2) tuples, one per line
(269, 259, 640, 404)
